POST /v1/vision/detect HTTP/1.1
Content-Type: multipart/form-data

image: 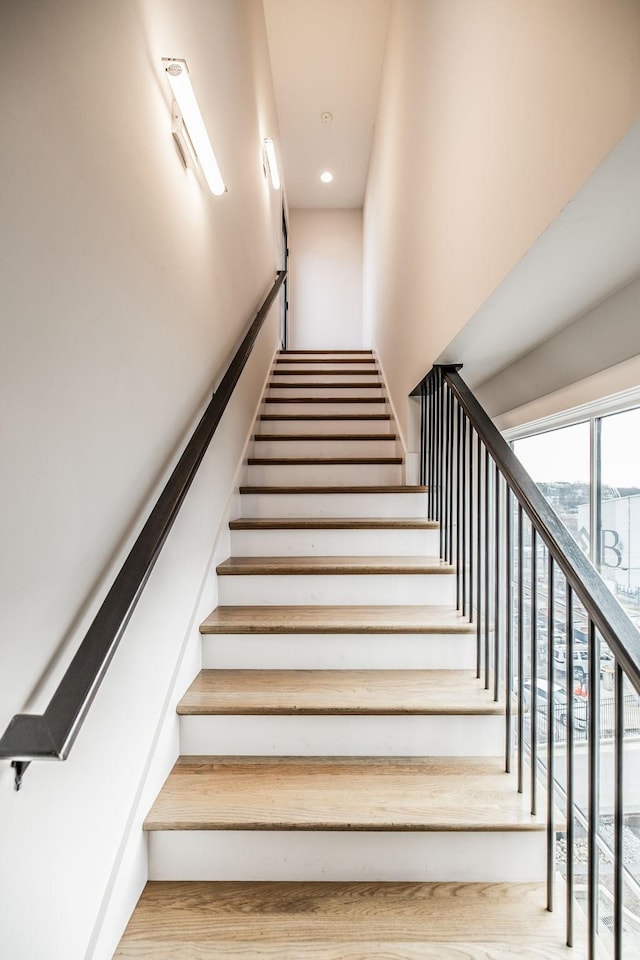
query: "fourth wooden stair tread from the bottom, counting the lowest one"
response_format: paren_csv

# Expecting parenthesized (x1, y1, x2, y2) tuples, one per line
(200, 605, 476, 634)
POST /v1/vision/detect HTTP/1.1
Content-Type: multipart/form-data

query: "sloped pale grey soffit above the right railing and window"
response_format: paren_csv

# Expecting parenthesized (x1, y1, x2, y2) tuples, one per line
(438, 121, 640, 386)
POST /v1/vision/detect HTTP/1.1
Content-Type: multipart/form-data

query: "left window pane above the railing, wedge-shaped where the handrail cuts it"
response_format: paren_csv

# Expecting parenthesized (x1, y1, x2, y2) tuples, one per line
(514, 422, 592, 554)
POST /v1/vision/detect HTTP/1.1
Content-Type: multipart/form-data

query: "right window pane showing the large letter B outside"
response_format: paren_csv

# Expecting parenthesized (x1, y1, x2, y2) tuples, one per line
(599, 409, 640, 626)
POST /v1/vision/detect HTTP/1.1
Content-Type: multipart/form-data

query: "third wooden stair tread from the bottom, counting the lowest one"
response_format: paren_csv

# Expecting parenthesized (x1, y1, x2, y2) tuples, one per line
(178, 670, 504, 716)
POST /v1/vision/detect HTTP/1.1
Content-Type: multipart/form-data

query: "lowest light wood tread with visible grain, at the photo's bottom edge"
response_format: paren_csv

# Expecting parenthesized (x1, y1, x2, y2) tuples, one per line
(115, 882, 585, 960)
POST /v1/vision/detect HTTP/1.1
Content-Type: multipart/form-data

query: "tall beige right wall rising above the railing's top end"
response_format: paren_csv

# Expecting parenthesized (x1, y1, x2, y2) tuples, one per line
(364, 0, 640, 438)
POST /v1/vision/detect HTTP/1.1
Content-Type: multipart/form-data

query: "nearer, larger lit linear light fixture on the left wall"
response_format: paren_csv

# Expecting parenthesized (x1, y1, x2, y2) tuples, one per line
(162, 57, 227, 197)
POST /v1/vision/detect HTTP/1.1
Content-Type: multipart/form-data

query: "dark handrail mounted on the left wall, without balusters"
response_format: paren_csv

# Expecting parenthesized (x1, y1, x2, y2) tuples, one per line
(0, 270, 286, 790)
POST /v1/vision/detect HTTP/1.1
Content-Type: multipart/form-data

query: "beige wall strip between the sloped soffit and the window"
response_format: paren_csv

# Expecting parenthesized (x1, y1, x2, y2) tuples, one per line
(476, 277, 640, 425)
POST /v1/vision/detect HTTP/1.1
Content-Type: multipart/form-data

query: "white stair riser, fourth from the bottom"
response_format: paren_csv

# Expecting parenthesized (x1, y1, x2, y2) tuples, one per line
(218, 574, 456, 606)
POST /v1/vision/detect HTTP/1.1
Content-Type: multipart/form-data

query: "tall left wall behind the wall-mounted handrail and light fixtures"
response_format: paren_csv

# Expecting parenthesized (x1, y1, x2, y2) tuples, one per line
(0, 0, 281, 960)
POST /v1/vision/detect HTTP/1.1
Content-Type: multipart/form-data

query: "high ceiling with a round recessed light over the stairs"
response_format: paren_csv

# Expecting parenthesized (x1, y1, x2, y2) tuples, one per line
(264, 0, 390, 207)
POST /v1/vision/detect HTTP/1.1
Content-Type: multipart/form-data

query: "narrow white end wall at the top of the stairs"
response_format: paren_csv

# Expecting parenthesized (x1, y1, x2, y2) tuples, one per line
(289, 209, 362, 350)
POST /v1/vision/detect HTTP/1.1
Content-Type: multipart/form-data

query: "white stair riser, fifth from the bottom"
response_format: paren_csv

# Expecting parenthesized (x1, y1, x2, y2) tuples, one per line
(231, 530, 440, 557)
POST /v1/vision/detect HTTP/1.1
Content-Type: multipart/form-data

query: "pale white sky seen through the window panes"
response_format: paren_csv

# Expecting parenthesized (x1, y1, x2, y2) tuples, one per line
(514, 408, 640, 487)
